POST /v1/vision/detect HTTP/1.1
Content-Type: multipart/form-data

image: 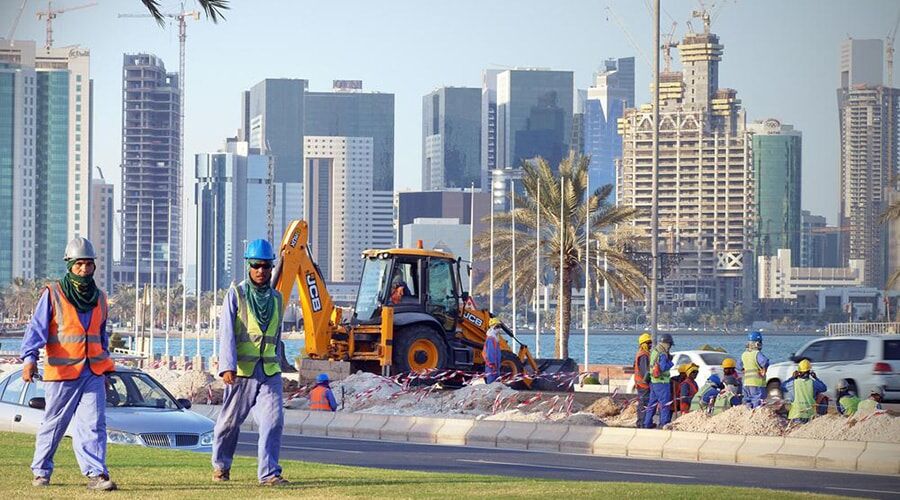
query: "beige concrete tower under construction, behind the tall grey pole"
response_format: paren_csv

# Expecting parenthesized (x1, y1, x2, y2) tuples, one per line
(616, 29, 753, 309)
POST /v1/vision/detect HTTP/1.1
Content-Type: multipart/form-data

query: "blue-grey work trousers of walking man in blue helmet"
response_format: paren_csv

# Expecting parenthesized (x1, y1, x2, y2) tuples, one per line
(212, 363, 284, 481)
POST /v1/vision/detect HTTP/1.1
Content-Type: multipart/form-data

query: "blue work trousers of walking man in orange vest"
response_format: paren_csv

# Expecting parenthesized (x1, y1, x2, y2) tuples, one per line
(31, 374, 109, 478)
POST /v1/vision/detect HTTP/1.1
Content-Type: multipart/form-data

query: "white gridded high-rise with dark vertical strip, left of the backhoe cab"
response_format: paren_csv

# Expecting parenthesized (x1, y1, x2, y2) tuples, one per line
(303, 136, 375, 282)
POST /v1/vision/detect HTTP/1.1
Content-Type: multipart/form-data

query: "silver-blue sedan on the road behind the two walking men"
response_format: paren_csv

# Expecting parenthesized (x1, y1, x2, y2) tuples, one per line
(0, 366, 214, 452)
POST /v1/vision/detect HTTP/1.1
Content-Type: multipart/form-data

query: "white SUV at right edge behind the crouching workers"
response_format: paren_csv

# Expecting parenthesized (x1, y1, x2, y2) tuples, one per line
(766, 335, 900, 400)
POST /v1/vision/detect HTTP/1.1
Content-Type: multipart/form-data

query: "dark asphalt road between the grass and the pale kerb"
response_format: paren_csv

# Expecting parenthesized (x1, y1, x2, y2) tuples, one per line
(238, 433, 900, 498)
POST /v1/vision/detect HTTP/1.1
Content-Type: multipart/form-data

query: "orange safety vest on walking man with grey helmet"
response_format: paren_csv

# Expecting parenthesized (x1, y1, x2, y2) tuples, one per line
(44, 283, 115, 381)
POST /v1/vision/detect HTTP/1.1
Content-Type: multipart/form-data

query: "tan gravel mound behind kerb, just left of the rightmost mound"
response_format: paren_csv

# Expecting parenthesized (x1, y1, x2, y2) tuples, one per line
(672, 406, 787, 436)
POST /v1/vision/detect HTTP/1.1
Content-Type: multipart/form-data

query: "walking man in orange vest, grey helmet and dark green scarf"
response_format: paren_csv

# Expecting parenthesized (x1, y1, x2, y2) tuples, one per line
(22, 238, 116, 491)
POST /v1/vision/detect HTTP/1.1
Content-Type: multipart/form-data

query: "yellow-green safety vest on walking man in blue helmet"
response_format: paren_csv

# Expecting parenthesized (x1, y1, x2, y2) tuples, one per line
(234, 281, 281, 377)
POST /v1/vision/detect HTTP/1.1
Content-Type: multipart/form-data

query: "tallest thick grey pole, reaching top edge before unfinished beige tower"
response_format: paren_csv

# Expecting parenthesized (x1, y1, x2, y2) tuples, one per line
(650, 0, 660, 343)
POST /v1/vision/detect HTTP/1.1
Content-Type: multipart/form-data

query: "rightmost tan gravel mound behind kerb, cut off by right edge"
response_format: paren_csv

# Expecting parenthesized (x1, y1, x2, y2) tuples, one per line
(788, 412, 900, 443)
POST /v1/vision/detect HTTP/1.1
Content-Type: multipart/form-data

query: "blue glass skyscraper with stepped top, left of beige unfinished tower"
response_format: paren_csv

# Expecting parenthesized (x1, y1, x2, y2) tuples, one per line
(582, 57, 634, 193)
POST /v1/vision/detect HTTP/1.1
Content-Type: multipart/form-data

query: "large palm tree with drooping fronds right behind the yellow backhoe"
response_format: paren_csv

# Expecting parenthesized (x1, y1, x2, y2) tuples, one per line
(475, 154, 646, 358)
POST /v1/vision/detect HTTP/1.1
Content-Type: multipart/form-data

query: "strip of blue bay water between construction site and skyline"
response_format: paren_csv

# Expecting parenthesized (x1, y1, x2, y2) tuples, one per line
(0, 332, 818, 365)
